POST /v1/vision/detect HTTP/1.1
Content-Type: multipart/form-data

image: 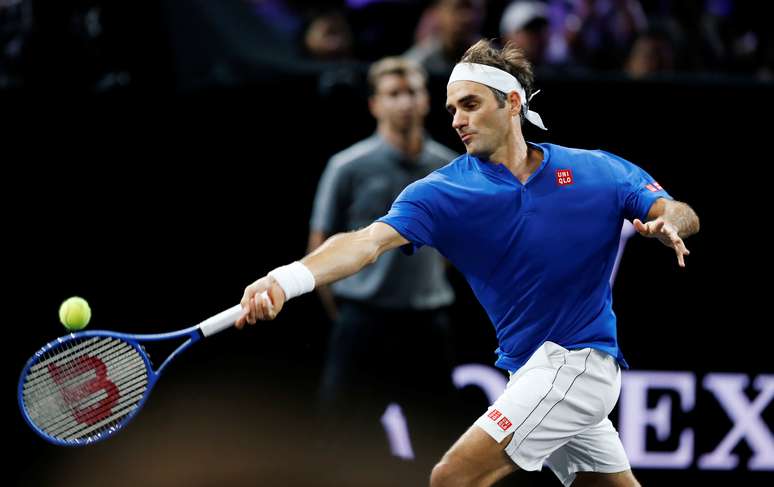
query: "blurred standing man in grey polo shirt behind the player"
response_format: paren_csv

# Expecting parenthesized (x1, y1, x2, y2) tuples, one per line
(309, 57, 464, 472)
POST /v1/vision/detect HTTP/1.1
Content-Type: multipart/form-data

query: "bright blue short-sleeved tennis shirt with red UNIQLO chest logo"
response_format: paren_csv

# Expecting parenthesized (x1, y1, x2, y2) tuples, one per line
(377, 144, 671, 371)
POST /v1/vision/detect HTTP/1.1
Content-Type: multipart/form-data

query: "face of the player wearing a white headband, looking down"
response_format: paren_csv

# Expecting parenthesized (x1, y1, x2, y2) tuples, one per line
(446, 81, 518, 159)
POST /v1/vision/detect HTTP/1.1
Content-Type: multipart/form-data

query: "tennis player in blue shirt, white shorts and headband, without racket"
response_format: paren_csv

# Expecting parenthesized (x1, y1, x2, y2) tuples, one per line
(237, 41, 699, 487)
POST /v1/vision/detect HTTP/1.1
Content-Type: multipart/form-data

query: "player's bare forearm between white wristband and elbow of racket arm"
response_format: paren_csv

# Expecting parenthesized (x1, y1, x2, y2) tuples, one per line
(301, 229, 380, 286)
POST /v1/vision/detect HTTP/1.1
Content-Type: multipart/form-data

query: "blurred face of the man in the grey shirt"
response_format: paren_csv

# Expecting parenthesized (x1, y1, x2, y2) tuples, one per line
(370, 73, 429, 132)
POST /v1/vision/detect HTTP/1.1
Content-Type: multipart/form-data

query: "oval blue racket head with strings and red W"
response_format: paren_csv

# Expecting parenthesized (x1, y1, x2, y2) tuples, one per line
(17, 330, 158, 446)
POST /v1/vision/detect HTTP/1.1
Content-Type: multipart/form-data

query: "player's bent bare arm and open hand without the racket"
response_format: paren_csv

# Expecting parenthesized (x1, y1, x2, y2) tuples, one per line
(633, 198, 699, 267)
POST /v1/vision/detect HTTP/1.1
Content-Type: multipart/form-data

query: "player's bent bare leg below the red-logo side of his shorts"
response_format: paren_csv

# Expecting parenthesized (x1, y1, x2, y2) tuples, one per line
(431, 425, 518, 486)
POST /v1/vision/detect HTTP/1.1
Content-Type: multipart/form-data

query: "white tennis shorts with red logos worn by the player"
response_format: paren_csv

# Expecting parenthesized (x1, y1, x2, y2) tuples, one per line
(475, 342, 630, 485)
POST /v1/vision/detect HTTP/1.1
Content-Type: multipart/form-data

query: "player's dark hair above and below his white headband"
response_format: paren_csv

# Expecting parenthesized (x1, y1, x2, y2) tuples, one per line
(460, 39, 535, 123)
